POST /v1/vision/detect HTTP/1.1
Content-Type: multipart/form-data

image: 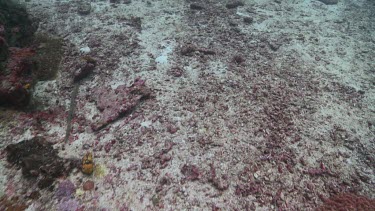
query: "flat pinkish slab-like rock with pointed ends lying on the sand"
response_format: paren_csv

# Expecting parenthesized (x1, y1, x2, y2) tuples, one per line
(92, 79, 151, 131)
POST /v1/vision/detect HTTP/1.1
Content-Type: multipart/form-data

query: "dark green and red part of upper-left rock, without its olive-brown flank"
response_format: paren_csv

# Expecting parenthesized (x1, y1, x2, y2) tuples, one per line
(0, 0, 36, 107)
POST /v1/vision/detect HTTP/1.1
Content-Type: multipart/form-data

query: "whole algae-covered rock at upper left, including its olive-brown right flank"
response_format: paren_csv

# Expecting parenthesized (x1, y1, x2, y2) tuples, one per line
(0, 0, 63, 108)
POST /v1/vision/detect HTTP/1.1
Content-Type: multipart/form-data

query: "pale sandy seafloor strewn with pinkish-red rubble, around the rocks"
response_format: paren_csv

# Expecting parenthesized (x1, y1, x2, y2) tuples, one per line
(0, 0, 375, 210)
